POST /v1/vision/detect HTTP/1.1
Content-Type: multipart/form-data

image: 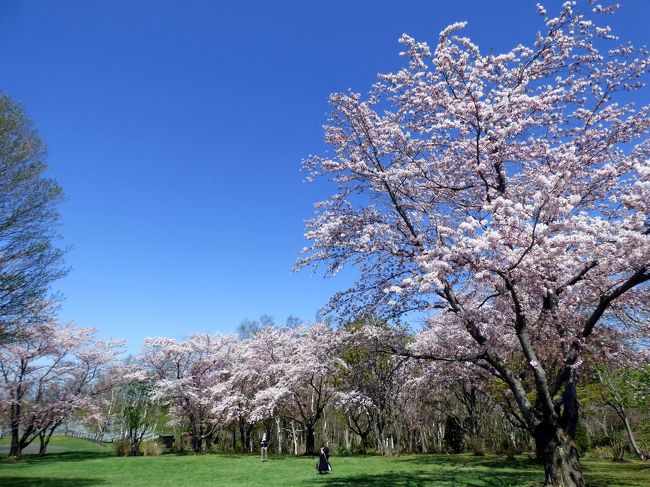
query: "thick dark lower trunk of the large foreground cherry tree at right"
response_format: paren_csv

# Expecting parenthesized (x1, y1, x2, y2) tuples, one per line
(535, 423, 585, 487)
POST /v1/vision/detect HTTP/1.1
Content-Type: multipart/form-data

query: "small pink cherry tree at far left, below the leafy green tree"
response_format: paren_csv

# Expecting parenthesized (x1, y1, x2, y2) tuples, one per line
(0, 322, 122, 458)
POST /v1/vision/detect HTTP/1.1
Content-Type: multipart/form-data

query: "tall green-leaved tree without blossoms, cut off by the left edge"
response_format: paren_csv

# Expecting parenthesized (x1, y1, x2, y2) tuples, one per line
(0, 93, 65, 343)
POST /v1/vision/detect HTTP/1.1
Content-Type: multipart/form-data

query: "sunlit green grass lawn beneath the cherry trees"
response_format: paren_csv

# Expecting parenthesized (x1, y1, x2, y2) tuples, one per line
(0, 438, 650, 487)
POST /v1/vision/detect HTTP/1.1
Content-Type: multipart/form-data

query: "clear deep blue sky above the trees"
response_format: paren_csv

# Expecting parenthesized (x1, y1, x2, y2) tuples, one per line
(0, 0, 650, 351)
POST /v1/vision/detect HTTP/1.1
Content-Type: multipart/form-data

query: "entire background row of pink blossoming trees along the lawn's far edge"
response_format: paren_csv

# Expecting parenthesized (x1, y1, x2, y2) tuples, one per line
(0, 319, 650, 482)
